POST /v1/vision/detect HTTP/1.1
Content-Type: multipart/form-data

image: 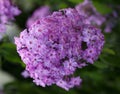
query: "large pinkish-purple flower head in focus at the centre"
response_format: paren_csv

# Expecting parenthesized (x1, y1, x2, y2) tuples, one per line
(15, 8, 104, 90)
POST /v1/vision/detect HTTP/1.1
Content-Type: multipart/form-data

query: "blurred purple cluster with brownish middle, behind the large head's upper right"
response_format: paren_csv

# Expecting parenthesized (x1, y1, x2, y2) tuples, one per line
(75, 0, 106, 26)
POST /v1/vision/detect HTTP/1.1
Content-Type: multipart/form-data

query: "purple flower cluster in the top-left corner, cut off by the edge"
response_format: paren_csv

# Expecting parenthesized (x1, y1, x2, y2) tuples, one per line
(0, 0, 20, 32)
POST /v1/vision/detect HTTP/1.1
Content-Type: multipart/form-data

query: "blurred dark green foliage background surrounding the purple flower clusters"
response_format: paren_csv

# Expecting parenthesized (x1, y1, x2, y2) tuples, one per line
(0, 0, 120, 94)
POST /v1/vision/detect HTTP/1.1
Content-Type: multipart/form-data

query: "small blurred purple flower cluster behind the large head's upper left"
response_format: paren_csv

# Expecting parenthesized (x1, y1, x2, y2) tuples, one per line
(27, 6, 50, 27)
